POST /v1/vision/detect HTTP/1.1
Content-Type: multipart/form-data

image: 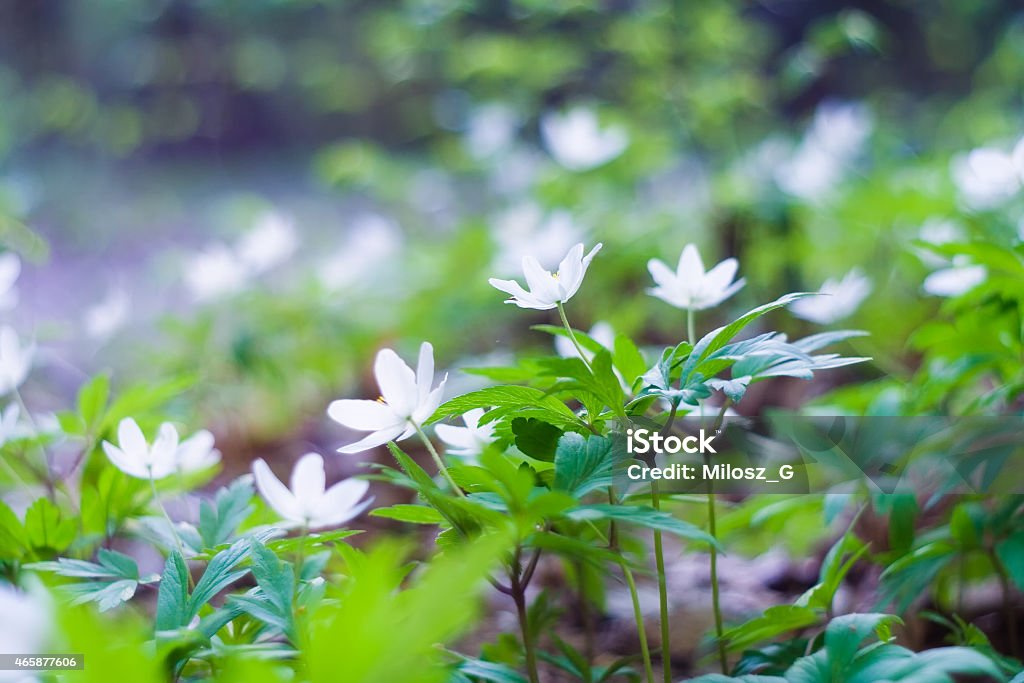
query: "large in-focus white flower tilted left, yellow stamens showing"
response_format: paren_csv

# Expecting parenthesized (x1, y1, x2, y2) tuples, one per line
(327, 342, 447, 453)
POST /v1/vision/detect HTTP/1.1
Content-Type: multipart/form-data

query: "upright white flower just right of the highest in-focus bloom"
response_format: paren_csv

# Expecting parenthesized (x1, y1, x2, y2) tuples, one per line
(647, 244, 745, 310)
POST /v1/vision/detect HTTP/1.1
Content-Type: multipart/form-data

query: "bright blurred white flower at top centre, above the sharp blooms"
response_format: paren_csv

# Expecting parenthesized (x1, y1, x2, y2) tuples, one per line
(541, 106, 630, 171)
